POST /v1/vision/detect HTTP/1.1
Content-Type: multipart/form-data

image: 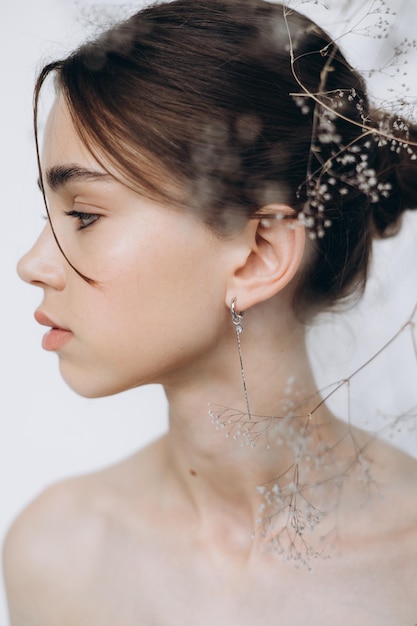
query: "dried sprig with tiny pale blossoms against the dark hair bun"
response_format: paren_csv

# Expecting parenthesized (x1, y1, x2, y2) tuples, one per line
(284, 0, 417, 239)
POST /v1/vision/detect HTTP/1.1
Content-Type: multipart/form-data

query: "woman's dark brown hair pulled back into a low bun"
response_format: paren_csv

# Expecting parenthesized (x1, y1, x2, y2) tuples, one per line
(35, 0, 417, 317)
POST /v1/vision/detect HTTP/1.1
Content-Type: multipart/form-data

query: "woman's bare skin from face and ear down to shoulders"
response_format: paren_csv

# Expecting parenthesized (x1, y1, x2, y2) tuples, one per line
(4, 97, 417, 626)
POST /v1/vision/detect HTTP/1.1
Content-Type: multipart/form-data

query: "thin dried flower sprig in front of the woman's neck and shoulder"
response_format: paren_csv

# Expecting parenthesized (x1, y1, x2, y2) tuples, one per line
(209, 303, 417, 569)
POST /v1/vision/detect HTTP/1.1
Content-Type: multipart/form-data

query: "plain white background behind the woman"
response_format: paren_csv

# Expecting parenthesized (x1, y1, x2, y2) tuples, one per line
(0, 0, 417, 625)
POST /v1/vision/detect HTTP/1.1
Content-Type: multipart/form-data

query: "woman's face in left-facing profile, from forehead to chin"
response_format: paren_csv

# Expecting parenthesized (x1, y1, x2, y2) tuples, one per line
(18, 98, 234, 397)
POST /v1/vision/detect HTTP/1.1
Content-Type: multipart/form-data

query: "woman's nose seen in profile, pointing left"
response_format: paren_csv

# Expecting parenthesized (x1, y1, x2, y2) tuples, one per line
(17, 224, 65, 290)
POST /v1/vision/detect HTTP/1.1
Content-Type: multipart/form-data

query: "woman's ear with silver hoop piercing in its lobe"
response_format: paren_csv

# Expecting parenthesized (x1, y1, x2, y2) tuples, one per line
(226, 204, 306, 310)
